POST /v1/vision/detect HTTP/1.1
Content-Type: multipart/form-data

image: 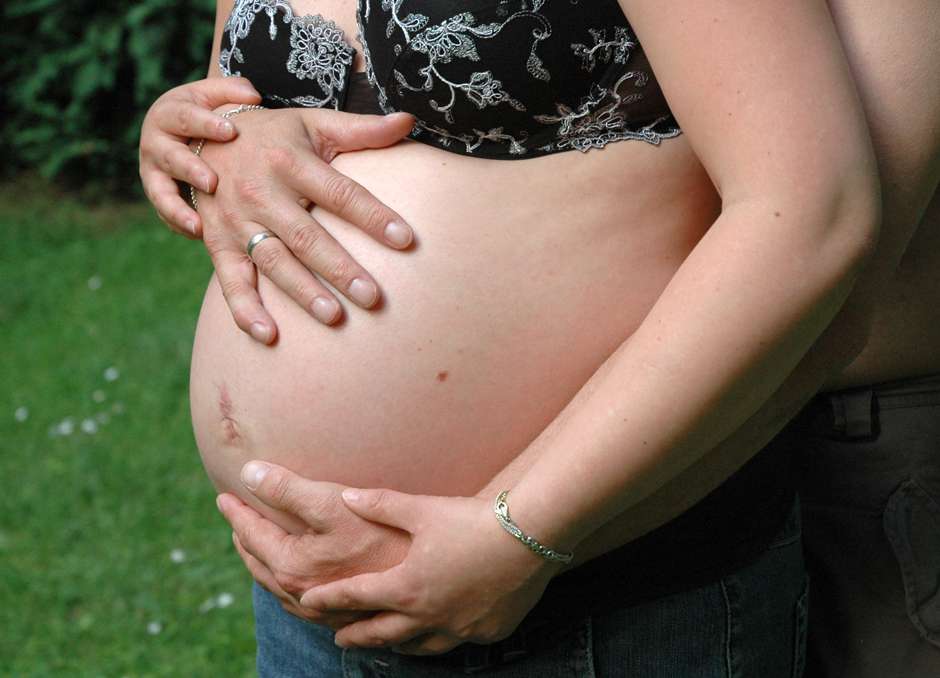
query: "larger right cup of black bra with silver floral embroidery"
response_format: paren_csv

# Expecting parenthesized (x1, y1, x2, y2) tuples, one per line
(359, 0, 680, 158)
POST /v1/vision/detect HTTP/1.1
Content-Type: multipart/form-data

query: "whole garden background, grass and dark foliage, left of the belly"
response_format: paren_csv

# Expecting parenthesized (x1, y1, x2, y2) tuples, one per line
(0, 5, 255, 678)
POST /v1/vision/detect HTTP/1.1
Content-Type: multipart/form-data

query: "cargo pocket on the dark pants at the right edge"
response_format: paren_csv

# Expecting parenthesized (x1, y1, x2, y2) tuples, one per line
(884, 480, 940, 647)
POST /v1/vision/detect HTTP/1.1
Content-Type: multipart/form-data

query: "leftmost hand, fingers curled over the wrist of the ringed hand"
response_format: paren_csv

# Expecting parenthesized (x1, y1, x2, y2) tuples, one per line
(140, 78, 261, 238)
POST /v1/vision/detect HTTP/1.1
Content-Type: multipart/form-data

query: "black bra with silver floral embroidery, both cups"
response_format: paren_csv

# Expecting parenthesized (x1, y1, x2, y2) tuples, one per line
(220, 0, 680, 159)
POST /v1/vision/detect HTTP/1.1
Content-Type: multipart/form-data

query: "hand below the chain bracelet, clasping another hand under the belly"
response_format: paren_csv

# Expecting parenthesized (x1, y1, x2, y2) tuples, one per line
(299, 490, 561, 654)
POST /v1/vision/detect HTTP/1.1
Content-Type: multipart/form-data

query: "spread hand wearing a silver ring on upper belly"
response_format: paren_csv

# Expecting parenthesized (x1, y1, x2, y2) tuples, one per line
(193, 108, 414, 343)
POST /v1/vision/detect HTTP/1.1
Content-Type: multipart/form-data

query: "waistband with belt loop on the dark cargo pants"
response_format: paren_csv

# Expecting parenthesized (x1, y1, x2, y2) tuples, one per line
(799, 374, 940, 441)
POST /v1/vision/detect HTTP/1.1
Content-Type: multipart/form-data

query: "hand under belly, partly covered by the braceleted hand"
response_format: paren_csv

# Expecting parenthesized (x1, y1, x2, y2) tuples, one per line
(218, 462, 411, 628)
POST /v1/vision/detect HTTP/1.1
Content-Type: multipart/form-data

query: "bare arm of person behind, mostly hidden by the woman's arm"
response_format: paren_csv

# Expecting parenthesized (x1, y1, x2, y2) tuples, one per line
(532, 0, 940, 562)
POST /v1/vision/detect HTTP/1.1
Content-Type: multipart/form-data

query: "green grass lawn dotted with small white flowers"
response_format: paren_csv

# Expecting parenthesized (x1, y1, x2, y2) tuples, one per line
(0, 182, 254, 677)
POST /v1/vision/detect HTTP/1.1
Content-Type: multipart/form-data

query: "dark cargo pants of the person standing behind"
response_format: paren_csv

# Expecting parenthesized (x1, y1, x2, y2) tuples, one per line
(799, 375, 940, 678)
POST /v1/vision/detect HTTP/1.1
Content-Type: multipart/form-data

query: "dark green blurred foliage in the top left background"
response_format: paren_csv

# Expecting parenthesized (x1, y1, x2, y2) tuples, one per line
(0, 0, 215, 195)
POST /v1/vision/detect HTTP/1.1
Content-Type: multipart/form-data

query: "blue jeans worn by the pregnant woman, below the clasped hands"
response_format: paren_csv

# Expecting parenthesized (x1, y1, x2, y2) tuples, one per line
(254, 496, 807, 678)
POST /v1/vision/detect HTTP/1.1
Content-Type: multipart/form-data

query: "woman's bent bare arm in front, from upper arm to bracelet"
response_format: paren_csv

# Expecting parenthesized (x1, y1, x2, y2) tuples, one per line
(484, 0, 878, 549)
